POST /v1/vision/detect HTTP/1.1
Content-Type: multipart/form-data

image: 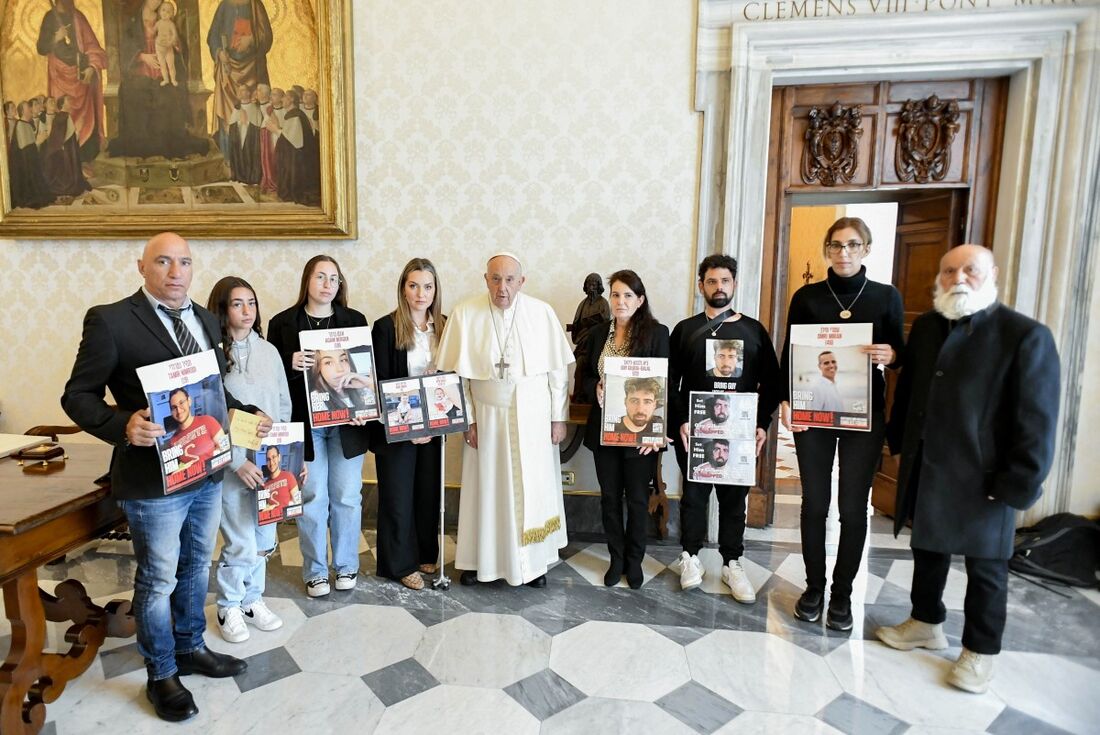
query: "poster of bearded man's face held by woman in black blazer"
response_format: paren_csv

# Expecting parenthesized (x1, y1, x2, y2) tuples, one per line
(600, 358, 669, 447)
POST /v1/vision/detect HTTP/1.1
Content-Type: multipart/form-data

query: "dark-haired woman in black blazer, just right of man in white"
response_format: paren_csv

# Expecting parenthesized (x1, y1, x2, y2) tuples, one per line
(578, 271, 669, 590)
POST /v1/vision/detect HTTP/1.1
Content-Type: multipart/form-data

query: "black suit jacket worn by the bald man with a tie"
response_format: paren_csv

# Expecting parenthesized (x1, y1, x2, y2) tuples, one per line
(62, 289, 257, 500)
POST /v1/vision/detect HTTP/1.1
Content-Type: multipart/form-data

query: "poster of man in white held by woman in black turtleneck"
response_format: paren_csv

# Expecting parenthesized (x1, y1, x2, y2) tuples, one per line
(790, 323, 872, 431)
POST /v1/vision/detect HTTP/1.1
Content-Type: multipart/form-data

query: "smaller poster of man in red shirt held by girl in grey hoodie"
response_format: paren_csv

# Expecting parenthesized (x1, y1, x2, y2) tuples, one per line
(248, 421, 306, 526)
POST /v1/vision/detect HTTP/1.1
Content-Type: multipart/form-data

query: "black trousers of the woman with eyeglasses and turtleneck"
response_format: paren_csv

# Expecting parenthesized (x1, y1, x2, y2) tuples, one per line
(794, 412, 886, 599)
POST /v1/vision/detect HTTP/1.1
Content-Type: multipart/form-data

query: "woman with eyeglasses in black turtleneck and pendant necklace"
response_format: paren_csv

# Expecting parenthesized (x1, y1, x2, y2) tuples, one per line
(781, 217, 904, 630)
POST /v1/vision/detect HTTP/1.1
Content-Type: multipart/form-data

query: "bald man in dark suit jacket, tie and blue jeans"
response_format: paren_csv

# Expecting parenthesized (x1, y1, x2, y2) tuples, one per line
(62, 232, 271, 722)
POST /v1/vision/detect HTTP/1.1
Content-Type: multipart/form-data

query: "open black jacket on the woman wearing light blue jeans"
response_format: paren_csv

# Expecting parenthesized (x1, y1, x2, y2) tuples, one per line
(267, 303, 370, 462)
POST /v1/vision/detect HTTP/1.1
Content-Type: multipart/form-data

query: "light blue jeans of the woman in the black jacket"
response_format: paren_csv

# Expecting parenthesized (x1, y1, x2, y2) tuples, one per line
(298, 426, 363, 582)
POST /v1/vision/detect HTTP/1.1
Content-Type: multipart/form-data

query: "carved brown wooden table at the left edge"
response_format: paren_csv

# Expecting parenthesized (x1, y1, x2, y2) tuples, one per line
(0, 445, 134, 735)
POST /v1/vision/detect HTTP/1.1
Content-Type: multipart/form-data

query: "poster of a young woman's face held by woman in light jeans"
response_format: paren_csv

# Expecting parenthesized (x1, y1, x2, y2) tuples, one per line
(298, 327, 381, 429)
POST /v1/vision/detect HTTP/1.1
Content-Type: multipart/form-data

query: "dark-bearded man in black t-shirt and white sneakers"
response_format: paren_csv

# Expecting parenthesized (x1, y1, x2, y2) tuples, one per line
(669, 255, 781, 604)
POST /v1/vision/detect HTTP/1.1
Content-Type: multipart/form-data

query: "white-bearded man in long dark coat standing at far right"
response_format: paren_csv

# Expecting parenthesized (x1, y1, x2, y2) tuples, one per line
(876, 245, 1059, 693)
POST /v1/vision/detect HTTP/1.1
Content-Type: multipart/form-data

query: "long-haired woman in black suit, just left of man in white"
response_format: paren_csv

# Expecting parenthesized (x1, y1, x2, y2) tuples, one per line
(371, 257, 446, 590)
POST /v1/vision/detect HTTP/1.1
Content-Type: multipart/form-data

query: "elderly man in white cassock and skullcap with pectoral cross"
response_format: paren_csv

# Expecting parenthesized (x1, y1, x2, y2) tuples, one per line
(436, 253, 573, 586)
